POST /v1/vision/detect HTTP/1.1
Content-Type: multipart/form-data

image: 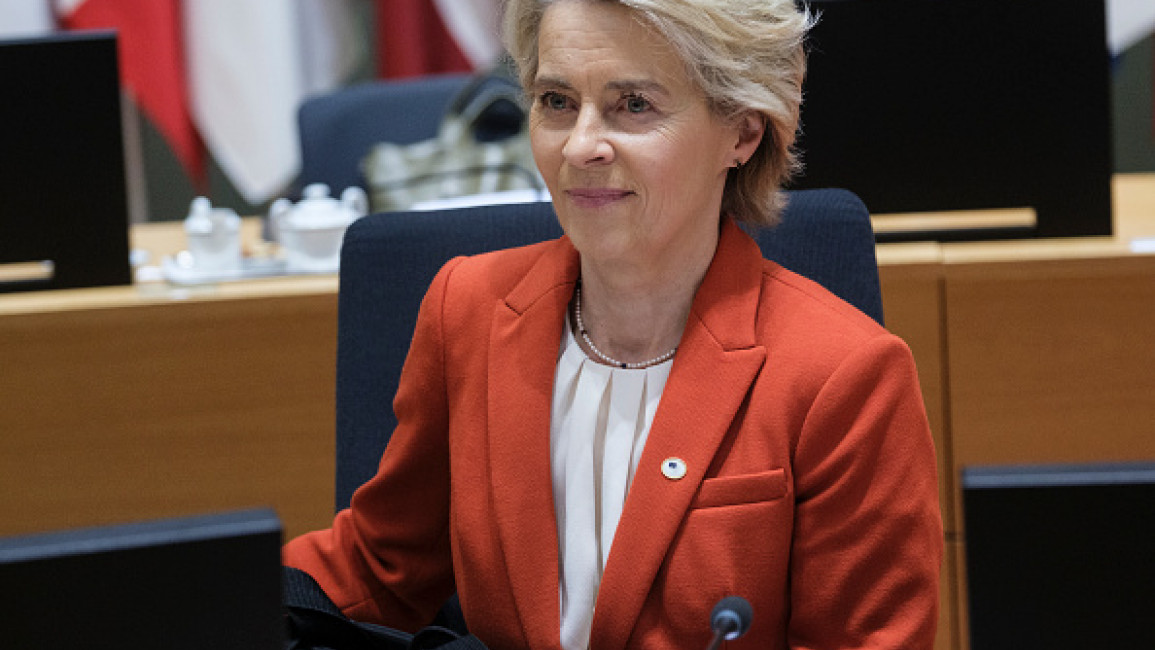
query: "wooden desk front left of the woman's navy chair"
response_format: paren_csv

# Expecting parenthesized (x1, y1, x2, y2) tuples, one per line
(0, 293, 336, 536)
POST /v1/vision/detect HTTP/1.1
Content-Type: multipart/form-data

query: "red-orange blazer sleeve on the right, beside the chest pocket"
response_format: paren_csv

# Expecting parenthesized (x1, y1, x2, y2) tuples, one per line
(788, 334, 942, 650)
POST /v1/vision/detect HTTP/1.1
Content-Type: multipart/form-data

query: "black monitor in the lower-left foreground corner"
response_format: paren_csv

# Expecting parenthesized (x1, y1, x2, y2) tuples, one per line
(0, 509, 284, 650)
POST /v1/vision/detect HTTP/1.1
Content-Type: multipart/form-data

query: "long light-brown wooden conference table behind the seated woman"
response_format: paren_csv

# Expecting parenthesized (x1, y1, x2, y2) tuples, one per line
(0, 174, 1155, 649)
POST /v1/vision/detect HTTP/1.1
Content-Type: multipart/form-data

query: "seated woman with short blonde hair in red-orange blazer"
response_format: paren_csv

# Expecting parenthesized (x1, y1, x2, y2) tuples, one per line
(284, 0, 941, 649)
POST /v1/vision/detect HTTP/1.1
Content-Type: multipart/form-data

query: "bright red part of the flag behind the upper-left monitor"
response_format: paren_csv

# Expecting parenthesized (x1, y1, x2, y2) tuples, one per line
(57, 0, 204, 184)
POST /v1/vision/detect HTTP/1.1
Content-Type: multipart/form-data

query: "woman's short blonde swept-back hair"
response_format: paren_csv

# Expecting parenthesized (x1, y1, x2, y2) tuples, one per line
(504, 0, 813, 225)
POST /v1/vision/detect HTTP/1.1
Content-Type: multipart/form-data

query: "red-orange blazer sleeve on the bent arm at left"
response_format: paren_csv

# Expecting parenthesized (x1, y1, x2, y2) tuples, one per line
(282, 260, 460, 632)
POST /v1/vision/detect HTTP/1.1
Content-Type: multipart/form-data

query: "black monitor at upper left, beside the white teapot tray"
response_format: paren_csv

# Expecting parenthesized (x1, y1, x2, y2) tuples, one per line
(0, 32, 132, 292)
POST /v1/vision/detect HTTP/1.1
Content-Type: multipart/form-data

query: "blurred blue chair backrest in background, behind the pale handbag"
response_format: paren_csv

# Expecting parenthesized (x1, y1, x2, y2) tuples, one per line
(297, 74, 471, 194)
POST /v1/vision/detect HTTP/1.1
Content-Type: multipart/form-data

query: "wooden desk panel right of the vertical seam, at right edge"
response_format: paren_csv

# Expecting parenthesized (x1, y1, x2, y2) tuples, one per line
(946, 256, 1155, 530)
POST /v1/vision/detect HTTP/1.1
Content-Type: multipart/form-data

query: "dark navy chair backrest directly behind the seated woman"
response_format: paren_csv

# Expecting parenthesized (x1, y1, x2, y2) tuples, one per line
(336, 189, 882, 509)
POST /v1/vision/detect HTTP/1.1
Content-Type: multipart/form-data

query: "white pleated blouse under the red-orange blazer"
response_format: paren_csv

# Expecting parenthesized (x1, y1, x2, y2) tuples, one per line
(550, 319, 673, 650)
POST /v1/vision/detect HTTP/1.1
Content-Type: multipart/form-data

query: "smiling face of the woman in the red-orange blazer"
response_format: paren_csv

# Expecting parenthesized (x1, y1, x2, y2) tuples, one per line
(530, 0, 757, 270)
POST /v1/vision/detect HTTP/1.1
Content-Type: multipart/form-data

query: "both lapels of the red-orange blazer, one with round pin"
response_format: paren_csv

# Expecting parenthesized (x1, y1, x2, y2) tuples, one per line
(487, 219, 766, 650)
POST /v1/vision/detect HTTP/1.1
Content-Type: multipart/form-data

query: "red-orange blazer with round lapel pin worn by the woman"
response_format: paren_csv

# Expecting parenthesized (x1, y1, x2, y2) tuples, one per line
(284, 221, 942, 650)
